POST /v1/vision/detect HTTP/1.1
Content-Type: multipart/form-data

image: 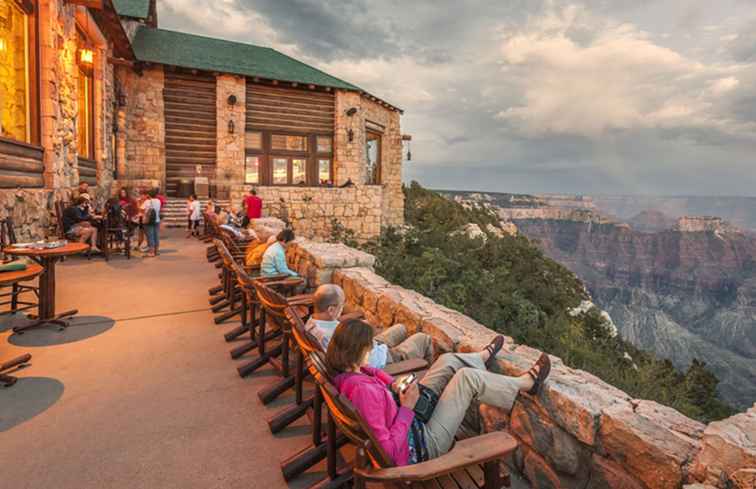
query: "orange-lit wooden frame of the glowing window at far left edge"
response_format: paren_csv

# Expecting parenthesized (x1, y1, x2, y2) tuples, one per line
(0, 0, 41, 149)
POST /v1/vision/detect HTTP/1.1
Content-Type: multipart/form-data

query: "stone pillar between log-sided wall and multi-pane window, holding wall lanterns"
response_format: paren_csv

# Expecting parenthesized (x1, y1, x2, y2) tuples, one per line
(216, 74, 247, 197)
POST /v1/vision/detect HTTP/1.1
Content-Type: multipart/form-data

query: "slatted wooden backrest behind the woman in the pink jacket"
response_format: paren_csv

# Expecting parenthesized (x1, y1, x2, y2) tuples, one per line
(308, 351, 394, 467)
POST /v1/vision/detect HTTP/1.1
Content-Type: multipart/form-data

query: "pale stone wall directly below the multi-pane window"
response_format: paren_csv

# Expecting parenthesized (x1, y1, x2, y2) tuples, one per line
(231, 185, 384, 240)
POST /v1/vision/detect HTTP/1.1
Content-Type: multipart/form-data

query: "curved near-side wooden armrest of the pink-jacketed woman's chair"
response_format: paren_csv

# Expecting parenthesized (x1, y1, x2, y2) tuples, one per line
(354, 431, 517, 483)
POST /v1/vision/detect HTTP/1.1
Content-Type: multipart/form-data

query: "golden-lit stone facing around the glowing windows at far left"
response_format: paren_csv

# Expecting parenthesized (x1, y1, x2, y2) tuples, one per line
(0, 0, 113, 240)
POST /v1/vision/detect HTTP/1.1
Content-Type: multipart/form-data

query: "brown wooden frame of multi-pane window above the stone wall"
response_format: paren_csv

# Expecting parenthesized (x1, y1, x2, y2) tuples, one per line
(244, 128, 334, 187)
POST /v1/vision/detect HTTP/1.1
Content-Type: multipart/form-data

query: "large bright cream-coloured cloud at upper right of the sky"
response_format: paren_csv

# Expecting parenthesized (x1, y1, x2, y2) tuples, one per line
(490, 6, 750, 139)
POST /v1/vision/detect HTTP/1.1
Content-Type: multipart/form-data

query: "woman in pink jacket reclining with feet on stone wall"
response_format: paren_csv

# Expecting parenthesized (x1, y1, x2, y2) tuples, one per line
(326, 320, 551, 466)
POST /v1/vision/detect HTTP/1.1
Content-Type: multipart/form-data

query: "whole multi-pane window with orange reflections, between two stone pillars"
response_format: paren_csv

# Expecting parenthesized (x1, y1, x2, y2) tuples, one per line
(245, 131, 333, 186)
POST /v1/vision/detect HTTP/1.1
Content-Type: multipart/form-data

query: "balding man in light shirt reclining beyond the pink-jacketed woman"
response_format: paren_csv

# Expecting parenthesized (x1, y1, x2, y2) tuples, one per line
(305, 284, 433, 368)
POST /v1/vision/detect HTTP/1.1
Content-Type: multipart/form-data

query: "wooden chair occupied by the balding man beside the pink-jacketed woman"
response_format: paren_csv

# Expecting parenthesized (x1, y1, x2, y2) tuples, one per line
(278, 307, 428, 481)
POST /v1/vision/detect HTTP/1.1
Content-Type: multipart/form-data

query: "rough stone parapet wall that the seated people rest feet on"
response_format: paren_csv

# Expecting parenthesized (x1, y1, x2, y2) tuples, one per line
(288, 241, 756, 489)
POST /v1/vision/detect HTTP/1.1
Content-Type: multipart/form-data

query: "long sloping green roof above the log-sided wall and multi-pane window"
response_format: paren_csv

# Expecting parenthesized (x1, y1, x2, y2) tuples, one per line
(132, 26, 362, 91)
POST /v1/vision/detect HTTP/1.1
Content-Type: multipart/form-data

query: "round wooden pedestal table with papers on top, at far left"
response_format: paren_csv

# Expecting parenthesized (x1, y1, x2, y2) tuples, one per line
(3, 243, 89, 334)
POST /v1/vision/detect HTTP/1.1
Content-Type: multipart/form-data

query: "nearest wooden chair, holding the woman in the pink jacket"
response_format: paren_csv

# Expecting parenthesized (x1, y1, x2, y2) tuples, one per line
(309, 352, 517, 489)
